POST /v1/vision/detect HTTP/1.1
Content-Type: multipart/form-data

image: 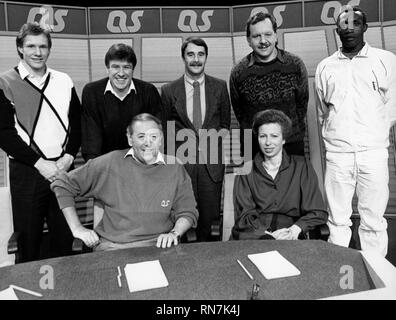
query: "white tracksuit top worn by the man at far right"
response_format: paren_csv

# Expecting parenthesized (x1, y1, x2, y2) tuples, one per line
(315, 43, 396, 152)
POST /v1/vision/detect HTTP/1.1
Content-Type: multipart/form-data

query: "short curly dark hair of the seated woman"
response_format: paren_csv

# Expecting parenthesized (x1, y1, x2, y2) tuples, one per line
(253, 109, 292, 140)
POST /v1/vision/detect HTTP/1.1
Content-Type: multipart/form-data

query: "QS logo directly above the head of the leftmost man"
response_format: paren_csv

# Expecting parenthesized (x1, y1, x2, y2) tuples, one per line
(27, 5, 69, 32)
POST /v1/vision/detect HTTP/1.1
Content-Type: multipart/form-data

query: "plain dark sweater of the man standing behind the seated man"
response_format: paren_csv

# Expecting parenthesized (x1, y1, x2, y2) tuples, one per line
(81, 78, 162, 161)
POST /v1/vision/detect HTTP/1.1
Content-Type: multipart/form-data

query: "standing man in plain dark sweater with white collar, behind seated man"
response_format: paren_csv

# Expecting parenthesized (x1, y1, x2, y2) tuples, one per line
(81, 43, 161, 161)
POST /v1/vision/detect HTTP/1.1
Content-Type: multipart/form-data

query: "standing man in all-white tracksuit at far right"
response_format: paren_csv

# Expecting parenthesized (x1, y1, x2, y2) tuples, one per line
(315, 7, 396, 256)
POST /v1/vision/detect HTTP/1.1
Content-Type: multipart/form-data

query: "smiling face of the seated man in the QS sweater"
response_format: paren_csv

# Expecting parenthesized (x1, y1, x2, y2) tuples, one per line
(127, 120, 162, 164)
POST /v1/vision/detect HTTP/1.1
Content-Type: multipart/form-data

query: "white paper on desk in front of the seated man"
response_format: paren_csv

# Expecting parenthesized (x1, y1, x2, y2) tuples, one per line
(124, 260, 169, 292)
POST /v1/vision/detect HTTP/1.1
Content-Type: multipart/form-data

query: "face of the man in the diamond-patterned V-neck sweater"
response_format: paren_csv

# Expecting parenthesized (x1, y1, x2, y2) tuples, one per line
(18, 34, 50, 75)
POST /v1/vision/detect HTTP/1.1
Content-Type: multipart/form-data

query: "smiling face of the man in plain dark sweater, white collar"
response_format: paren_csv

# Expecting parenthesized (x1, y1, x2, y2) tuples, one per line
(107, 60, 133, 95)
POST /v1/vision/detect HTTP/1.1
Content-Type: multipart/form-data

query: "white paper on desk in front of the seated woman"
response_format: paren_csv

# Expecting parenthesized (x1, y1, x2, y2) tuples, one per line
(248, 250, 301, 279)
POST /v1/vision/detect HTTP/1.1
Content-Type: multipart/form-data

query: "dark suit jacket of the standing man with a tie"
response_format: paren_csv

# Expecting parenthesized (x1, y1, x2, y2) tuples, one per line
(161, 75, 231, 182)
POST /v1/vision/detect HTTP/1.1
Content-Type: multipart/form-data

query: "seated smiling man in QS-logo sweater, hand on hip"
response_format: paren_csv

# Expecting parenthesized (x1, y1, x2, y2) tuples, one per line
(51, 113, 198, 250)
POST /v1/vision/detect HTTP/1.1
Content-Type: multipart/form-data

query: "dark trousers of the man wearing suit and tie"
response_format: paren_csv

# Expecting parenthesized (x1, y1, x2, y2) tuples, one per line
(185, 164, 223, 242)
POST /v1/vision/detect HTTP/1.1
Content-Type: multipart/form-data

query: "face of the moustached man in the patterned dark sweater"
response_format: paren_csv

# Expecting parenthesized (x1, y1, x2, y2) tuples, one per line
(247, 19, 278, 62)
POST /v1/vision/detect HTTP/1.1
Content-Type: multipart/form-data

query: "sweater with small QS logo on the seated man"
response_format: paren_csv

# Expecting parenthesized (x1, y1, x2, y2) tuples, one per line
(51, 150, 198, 243)
